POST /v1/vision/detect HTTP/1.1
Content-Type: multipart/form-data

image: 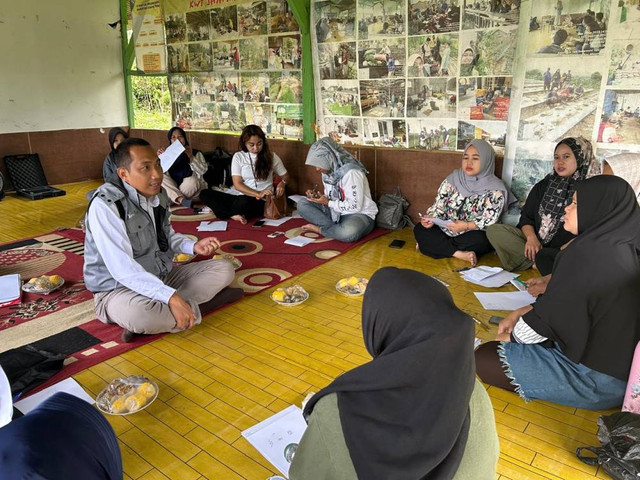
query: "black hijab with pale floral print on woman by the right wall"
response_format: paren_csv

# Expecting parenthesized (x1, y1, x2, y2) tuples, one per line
(538, 137, 595, 245)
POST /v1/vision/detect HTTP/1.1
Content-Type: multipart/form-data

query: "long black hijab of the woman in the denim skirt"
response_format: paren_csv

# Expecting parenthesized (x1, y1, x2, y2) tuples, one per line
(523, 175, 640, 382)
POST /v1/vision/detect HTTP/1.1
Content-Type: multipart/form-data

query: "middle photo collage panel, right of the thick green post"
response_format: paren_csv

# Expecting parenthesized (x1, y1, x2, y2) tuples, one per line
(311, 0, 520, 154)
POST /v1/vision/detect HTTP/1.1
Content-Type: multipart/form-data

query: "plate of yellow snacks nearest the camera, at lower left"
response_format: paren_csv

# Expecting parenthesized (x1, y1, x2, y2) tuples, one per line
(96, 375, 158, 415)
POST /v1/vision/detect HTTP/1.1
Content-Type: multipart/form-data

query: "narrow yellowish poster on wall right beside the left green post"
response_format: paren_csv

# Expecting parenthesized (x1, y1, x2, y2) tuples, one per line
(131, 0, 167, 73)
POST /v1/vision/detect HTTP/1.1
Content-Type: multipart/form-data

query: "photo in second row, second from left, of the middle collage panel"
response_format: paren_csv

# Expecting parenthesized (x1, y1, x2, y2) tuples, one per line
(358, 38, 406, 80)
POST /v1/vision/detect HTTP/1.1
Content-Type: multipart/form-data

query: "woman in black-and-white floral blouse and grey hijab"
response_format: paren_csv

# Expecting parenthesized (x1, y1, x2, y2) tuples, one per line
(413, 140, 509, 265)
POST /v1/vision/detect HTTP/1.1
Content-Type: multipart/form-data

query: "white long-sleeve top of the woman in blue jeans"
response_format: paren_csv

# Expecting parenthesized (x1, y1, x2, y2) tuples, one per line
(324, 169, 378, 219)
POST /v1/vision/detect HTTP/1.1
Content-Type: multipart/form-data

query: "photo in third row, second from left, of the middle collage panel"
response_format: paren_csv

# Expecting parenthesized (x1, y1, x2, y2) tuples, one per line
(360, 79, 405, 118)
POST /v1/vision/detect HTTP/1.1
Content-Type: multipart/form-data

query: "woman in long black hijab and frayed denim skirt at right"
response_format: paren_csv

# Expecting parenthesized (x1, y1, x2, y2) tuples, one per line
(476, 175, 640, 409)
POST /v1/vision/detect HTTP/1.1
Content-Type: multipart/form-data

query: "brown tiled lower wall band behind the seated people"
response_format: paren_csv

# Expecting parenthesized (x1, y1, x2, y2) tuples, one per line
(0, 128, 502, 218)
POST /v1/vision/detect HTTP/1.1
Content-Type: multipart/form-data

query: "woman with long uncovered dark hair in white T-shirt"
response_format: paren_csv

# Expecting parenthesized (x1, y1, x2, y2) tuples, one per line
(200, 125, 289, 224)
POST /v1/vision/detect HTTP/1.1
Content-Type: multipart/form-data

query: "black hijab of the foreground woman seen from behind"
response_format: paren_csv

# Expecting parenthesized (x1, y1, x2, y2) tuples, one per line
(304, 267, 475, 480)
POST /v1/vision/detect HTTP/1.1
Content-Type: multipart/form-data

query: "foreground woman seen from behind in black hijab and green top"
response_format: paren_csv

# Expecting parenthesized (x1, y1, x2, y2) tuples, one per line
(289, 267, 498, 480)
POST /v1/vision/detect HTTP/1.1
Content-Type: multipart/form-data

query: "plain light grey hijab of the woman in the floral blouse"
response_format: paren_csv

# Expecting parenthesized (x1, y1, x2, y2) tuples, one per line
(447, 139, 515, 210)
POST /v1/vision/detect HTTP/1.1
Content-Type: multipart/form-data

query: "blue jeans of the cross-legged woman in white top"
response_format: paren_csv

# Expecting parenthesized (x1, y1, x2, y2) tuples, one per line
(298, 198, 375, 242)
